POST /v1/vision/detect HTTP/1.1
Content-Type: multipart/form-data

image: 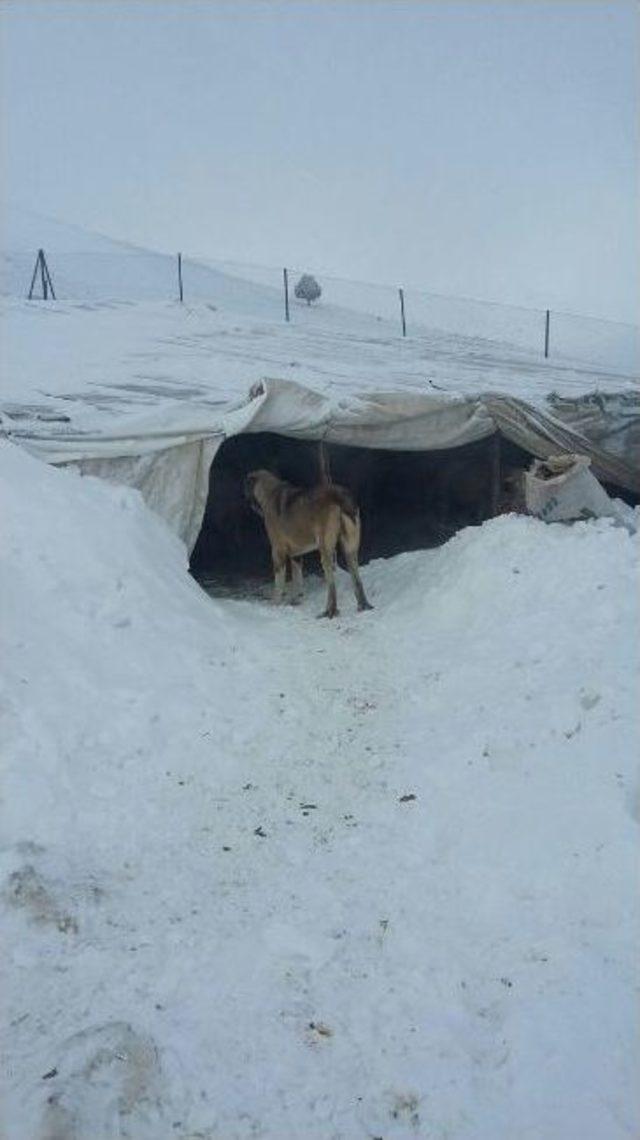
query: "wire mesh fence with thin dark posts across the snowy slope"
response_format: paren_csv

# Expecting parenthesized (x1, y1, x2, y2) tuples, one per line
(0, 249, 640, 376)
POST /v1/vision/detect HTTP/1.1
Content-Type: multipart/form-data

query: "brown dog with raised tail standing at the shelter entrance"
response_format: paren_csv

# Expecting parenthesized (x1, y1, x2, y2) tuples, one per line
(244, 471, 373, 618)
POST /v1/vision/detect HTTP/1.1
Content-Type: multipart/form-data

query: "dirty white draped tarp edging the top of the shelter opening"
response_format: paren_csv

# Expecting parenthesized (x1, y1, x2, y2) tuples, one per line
(2, 380, 640, 551)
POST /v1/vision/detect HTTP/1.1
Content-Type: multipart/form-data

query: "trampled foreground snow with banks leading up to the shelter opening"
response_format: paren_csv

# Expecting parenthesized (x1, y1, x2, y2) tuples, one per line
(0, 437, 640, 1140)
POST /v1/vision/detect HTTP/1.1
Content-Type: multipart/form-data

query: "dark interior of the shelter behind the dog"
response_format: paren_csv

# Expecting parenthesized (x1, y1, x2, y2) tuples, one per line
(191, 432, 533, 584)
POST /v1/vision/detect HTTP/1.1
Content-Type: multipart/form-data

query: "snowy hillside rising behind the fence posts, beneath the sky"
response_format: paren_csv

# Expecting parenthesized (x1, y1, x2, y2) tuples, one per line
(0, 206, 640, 376)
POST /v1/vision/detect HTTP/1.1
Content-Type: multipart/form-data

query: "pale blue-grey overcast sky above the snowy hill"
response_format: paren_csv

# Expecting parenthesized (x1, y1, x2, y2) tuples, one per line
(1, 0, 640, 320)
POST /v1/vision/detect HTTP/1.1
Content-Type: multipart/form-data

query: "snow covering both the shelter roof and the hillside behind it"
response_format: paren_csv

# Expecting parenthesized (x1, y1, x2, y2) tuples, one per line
(0, 207, 638, 440)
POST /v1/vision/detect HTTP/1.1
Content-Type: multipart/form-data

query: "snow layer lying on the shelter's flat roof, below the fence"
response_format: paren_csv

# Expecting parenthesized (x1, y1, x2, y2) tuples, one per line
(0, 301, 638, 471)
